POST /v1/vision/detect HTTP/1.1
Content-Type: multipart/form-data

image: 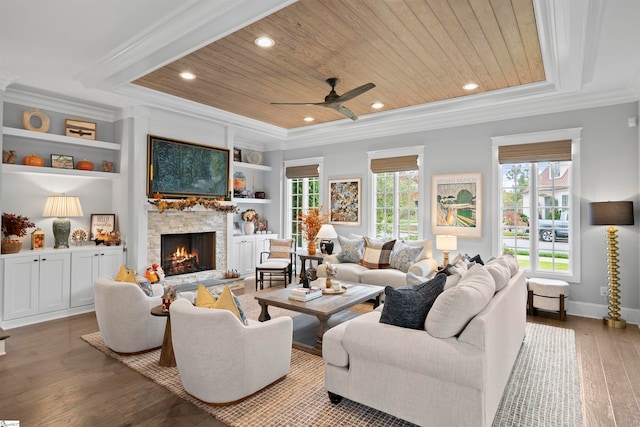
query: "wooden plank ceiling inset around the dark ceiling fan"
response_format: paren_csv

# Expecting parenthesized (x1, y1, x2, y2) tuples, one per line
(133, 0, 545, 129)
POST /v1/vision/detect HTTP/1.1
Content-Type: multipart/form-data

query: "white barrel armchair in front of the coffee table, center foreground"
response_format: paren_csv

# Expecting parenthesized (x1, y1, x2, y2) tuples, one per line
(169, 299, 293, 405)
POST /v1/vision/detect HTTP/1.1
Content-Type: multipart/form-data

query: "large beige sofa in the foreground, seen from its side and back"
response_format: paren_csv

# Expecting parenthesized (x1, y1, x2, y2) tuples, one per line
(323, 256, 527, 426)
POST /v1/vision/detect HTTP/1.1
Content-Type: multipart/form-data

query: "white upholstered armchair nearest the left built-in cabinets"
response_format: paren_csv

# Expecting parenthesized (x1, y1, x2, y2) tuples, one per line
(93, 277, 167, 353)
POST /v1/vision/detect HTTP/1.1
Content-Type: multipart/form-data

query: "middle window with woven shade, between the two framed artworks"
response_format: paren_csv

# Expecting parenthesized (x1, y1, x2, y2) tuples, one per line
(370, 150, 421, 240)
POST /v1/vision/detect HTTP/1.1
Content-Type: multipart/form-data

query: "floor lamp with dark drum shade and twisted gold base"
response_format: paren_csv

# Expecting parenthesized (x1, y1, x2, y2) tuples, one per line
(590, 201, 633, 329)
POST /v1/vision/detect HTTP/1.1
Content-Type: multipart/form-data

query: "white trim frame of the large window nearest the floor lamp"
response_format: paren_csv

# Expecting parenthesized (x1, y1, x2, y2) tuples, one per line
(491, 127, 582, 283)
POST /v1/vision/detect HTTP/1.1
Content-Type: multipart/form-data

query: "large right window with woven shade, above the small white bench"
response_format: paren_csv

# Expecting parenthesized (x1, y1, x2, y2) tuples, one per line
(494, 130, 580, 281)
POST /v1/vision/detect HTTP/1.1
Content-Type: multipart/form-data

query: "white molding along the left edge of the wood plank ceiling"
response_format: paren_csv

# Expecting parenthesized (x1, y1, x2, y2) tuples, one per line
(74, 0, 295, 90)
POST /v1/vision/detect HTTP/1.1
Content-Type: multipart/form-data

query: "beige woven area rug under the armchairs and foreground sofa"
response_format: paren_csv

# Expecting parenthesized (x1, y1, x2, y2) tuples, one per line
(82, 295, 582, 427)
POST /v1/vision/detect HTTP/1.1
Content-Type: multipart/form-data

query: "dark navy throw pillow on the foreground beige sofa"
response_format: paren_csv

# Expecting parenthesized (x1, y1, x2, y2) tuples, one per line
(380, 274, 447, 329)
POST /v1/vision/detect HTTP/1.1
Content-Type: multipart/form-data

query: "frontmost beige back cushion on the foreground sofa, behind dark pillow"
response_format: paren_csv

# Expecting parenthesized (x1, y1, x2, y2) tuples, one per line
(425, 264, 496, 338)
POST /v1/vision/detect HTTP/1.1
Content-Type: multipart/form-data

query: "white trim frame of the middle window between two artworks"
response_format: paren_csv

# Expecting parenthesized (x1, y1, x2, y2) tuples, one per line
(367, 146, 426, 240)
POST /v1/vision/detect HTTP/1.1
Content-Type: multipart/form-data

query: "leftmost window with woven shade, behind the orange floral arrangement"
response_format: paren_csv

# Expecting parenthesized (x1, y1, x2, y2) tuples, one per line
(285, 159, 322, 248)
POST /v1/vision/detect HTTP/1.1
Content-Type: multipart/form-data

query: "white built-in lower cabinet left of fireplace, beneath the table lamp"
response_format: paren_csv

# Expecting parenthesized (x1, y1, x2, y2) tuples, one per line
(0, 246, 124, 328)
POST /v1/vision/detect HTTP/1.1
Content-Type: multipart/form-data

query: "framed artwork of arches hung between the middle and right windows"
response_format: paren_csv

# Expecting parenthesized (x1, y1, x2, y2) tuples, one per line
(431, 173, 482, 238)
